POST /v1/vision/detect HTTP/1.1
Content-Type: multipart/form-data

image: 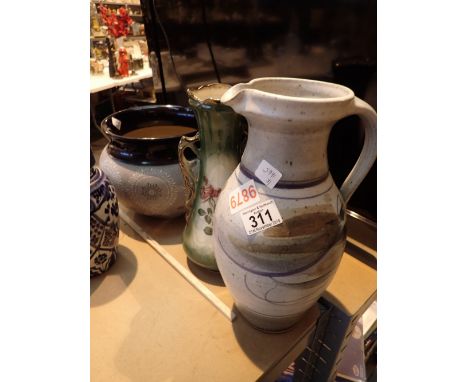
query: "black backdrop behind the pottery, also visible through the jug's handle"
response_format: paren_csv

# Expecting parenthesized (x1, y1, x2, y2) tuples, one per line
(134, 0, 377, 221)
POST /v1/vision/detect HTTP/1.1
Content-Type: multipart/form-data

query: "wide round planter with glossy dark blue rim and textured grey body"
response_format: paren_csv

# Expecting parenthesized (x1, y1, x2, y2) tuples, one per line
(99, 105, 197, 218)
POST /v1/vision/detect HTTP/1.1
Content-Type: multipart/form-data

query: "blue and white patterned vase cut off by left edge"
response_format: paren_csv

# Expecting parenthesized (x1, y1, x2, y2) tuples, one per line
(90, 153, 119, 277)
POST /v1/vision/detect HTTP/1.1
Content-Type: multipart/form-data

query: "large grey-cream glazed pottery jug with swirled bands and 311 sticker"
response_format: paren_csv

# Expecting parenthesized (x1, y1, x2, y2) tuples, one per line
(214, 78, 377, 331)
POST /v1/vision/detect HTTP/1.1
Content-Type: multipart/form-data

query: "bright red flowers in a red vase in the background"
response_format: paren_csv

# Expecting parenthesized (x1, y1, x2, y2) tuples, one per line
(99, 5, 133, 77)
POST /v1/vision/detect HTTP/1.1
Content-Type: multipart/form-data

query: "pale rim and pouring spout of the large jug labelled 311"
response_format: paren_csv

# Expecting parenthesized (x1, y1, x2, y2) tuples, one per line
(221, 77, 355, 103)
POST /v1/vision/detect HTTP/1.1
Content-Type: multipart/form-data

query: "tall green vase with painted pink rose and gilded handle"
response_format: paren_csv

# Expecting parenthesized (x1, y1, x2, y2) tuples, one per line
(179, 83, 246, 270)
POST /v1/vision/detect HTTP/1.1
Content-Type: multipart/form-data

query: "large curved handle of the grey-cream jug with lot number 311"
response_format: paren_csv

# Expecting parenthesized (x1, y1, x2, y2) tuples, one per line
(340, 97, 377, 205)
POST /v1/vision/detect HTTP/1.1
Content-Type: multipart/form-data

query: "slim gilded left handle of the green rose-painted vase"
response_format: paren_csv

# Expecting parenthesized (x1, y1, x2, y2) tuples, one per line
(178, 132, 200, 221)
